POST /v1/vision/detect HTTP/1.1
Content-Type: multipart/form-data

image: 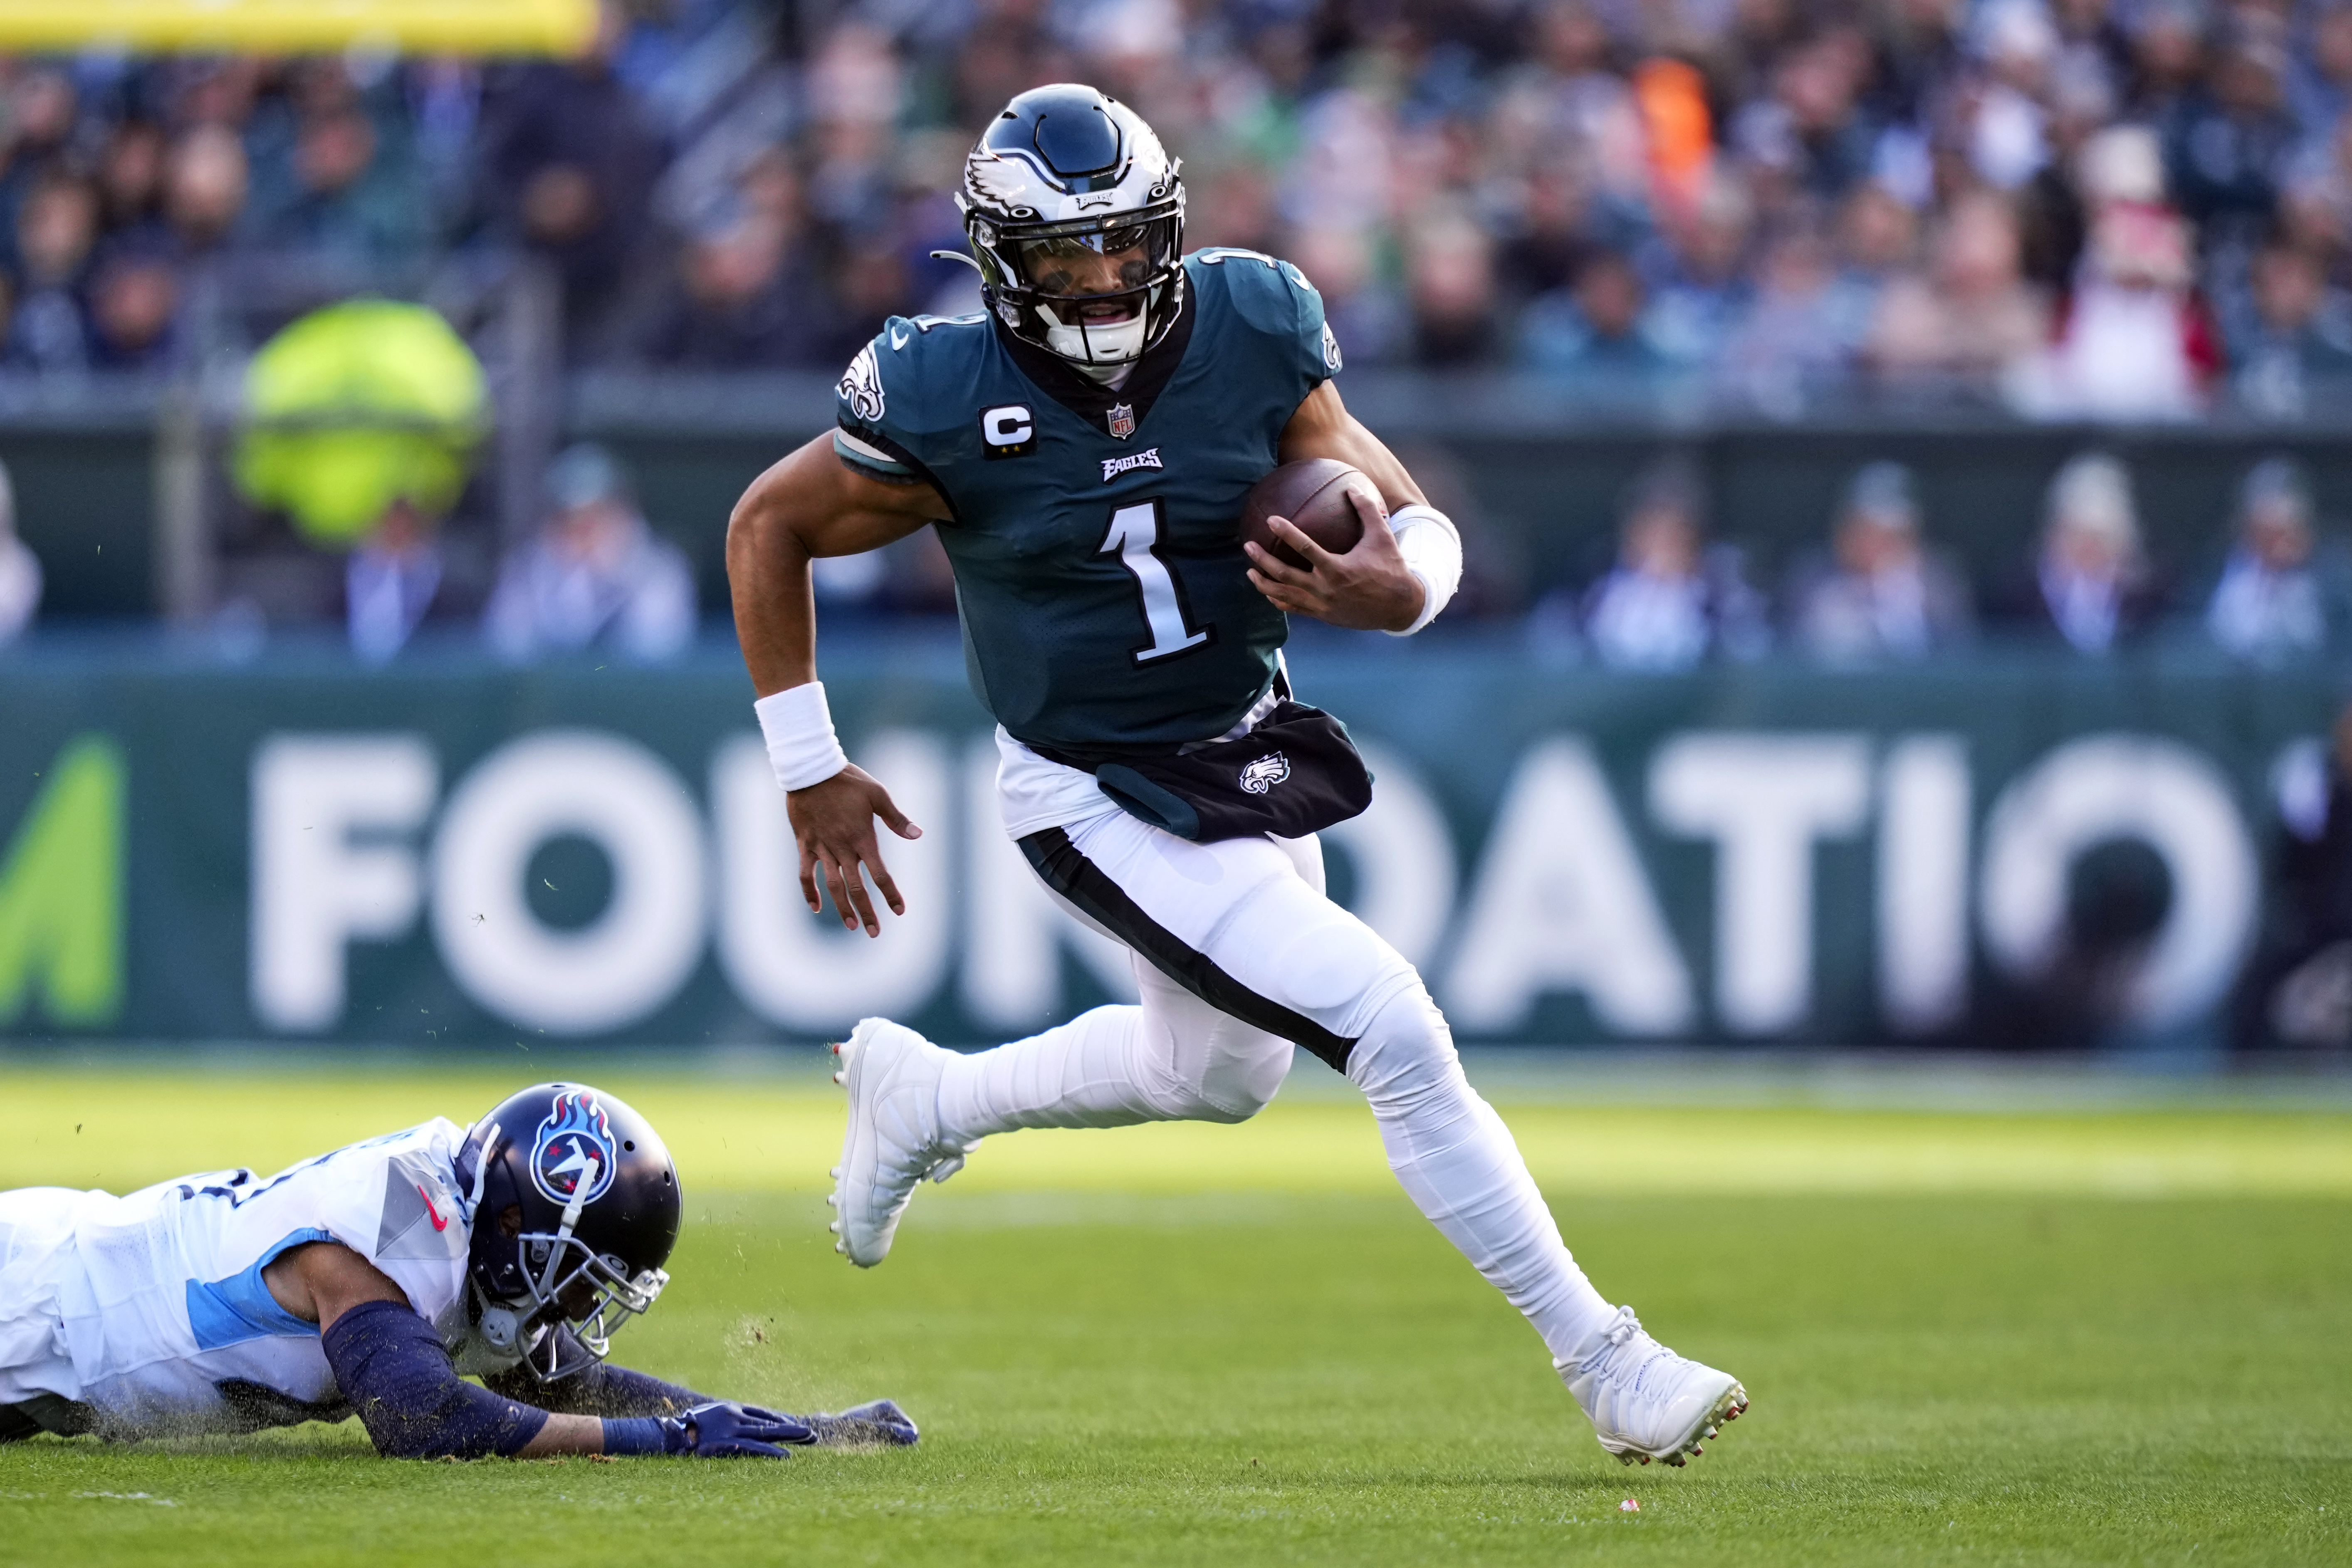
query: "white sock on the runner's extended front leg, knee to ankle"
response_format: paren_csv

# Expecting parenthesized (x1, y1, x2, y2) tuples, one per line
(1348, 985, 1616, 1361)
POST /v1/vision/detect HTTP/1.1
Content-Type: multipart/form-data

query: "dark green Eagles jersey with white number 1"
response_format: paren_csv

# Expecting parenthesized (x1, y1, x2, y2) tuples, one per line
(835, 249, 1338, 750)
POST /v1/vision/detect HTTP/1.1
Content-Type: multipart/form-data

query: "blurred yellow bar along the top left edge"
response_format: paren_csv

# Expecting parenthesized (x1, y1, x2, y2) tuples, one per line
(0, 0, 597, 54)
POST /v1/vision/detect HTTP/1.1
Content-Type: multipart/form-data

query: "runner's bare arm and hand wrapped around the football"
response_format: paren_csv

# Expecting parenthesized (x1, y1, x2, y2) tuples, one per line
(1242, 381, 1428, 632)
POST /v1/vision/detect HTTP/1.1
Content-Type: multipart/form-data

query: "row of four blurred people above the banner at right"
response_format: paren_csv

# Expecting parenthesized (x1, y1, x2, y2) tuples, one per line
(1529, 451, 2352, 673)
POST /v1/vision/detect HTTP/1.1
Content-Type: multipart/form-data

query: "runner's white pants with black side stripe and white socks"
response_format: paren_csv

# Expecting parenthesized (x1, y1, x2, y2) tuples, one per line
(938, 811, 1613, 1359)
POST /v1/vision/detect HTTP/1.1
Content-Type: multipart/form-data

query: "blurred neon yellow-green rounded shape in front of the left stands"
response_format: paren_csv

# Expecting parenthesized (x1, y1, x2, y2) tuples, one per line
(235, 299, 489, 548)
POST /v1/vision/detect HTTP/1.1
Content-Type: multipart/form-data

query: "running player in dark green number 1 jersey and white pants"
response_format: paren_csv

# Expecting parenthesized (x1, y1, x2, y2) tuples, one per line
(727, 84, 1748, 1464)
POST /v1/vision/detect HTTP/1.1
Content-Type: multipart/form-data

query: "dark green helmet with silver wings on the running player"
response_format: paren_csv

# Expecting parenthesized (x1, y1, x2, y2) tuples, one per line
(955, 82, 1183, 369)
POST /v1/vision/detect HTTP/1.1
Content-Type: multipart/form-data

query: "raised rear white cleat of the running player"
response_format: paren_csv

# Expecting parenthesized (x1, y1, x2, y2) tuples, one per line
(826, 1018, 972, 1269)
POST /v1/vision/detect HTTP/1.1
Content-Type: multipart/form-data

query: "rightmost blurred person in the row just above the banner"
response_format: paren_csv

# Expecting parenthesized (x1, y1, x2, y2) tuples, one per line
(2206, 456, 2340, 665)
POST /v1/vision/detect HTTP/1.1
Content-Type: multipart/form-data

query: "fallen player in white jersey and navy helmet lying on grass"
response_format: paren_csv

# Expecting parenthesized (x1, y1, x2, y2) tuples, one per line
(0, 1084, 915, 1460)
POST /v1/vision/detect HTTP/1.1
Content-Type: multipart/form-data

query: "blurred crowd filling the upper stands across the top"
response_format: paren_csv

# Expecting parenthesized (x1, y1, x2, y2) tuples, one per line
(0, 0, 2352, 418)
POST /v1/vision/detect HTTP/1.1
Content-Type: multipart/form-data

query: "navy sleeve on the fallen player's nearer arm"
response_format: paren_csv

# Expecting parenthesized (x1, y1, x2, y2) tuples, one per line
(322, 1302, 548, 1460)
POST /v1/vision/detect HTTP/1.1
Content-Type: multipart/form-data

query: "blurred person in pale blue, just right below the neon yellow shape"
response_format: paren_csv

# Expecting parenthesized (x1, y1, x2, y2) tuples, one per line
(482, 444, 694, 663)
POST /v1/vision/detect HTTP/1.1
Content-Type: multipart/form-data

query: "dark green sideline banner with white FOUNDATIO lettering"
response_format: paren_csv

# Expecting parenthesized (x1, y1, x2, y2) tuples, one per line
(0, 642, 2335, 1049)
